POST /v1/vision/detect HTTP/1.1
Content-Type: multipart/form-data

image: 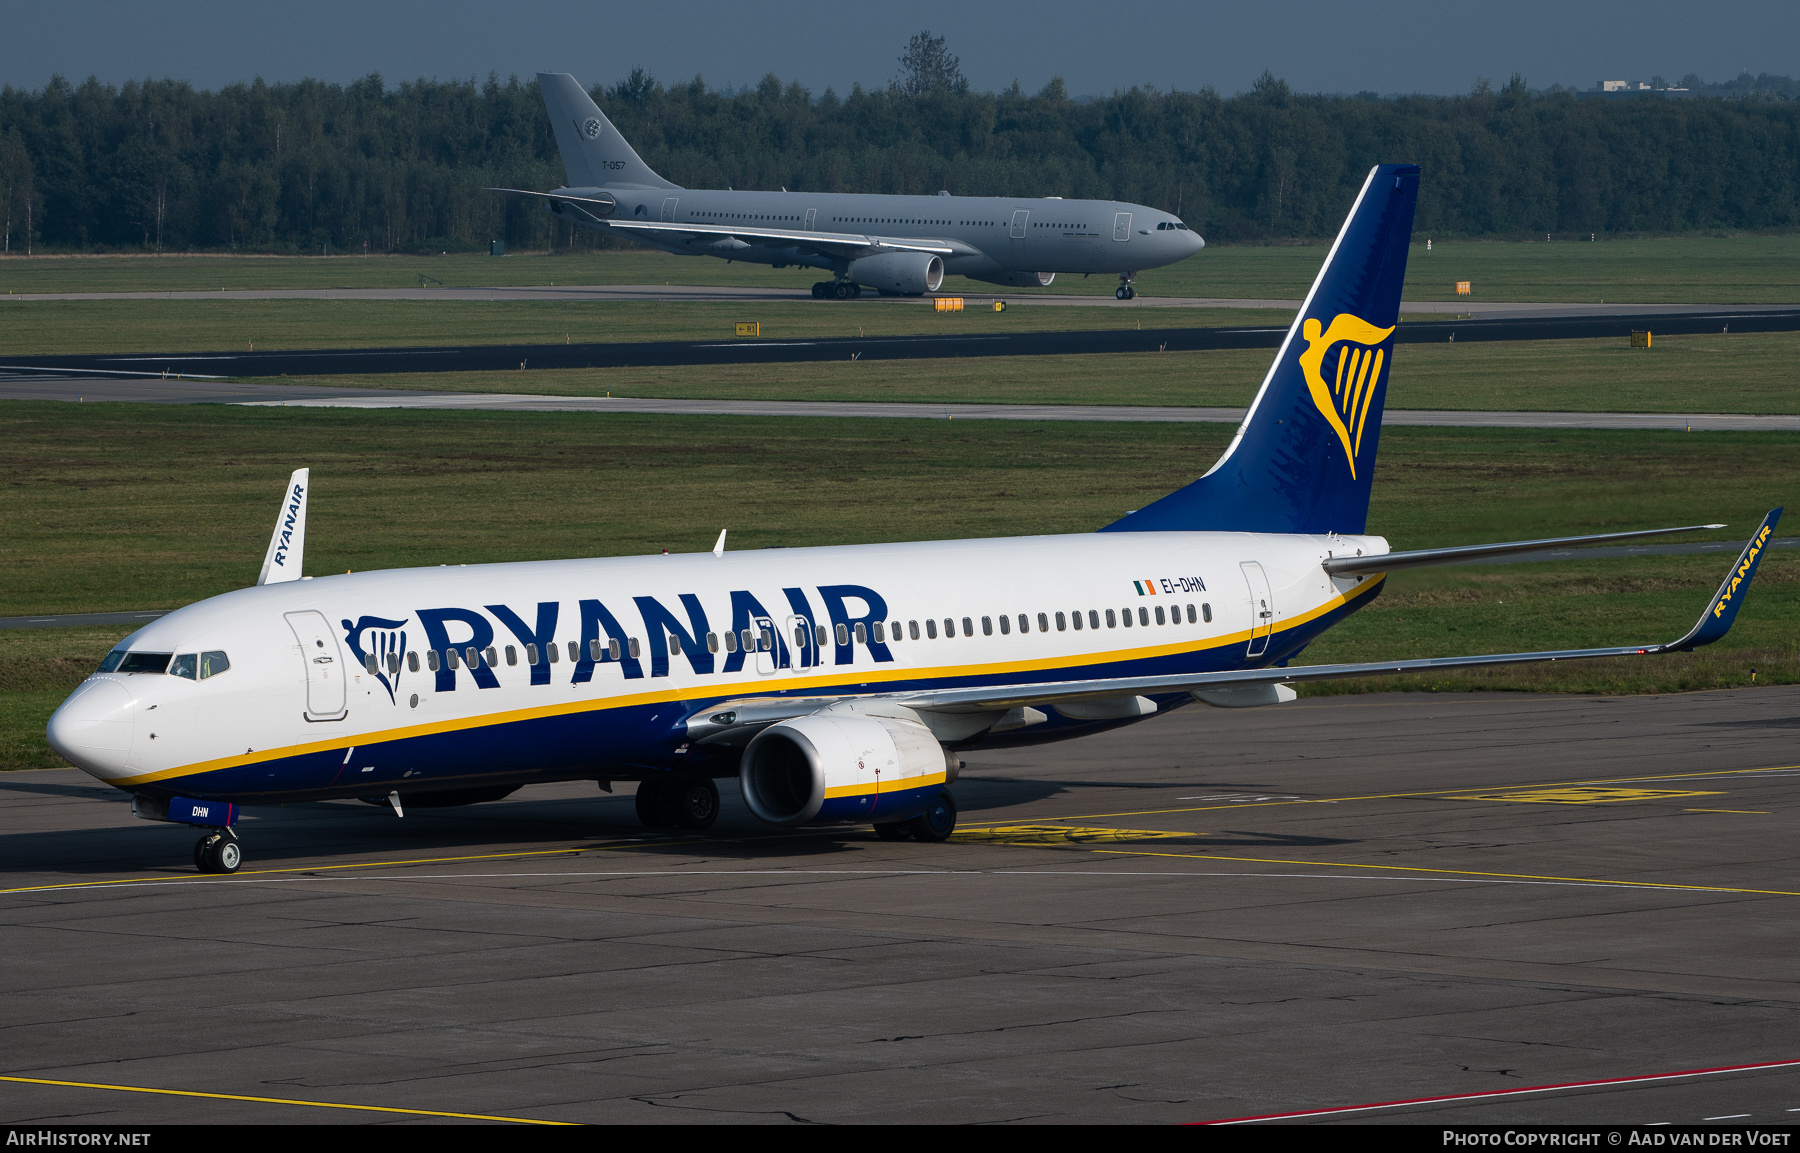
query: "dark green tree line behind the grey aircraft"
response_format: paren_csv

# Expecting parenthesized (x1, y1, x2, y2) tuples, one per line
(0, 70, 1800, 254)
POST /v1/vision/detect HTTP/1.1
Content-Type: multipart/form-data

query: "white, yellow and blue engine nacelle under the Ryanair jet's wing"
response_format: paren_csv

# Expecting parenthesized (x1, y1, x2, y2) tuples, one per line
(738, 714, 950, 826)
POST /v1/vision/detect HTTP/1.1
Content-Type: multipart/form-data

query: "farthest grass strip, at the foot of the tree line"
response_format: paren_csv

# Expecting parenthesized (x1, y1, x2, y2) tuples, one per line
(0, 236, 1800, 308)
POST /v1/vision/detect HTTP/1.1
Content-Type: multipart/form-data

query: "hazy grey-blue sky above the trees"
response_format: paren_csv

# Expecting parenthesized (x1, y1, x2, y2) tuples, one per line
(0, 0, 1800, 95)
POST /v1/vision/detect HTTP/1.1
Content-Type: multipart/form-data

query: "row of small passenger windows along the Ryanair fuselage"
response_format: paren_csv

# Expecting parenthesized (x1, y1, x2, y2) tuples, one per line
(378, 604, 1213, 676)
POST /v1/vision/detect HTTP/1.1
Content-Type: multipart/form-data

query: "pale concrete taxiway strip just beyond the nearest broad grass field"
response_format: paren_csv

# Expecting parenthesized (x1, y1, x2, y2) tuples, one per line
(0, 372, 1800, 432)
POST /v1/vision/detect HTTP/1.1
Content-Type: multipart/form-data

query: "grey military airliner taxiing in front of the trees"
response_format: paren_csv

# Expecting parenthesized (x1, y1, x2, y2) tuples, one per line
(490, 72, 1206, 300)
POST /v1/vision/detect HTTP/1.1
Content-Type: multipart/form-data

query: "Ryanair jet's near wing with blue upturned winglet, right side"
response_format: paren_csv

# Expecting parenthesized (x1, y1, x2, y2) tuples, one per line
(688, 509, 1782, 737)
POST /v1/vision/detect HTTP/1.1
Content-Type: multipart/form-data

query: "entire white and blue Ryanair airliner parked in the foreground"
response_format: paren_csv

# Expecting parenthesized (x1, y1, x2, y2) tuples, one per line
(49, 165, 1780, 872)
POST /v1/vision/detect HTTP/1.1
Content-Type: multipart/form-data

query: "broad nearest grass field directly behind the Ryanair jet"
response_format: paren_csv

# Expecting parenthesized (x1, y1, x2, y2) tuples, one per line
(0, 401, 1800, 768)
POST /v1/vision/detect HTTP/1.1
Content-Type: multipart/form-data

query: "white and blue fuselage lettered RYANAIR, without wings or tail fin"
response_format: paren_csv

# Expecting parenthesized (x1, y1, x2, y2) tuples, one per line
(49, 532, 1388, 800)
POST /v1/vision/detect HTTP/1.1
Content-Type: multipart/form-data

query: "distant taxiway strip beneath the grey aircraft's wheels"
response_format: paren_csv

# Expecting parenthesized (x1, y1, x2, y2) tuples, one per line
(5, 282, 1795, 320)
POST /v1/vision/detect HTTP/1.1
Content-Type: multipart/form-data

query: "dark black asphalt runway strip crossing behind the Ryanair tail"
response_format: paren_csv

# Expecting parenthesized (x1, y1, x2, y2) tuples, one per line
(0, 308, 1800, 378)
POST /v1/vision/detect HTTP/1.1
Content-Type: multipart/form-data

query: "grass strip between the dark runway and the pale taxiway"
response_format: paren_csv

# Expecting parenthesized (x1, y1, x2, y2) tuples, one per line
(259, 333, 1800, 414)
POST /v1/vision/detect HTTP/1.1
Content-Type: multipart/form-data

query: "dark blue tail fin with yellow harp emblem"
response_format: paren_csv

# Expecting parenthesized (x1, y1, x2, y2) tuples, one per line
(1102, 164, 1418, 532)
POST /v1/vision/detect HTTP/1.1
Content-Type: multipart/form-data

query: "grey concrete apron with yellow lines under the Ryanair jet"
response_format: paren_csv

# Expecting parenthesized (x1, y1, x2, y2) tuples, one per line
(10, 687, 1800, 1124)
